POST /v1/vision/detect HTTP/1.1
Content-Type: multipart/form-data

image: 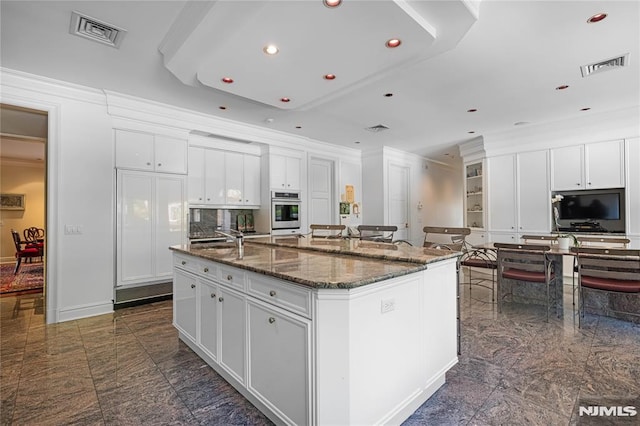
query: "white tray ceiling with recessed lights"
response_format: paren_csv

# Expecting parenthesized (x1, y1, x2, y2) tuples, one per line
(0, 0, 640, 162)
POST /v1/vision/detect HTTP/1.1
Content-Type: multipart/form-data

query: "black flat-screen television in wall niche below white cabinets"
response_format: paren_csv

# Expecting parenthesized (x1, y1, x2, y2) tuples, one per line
(555, 188, 625, 232)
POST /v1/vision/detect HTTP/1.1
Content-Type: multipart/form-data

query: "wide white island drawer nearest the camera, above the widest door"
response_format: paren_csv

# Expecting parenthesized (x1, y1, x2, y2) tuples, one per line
(247, 274, 311, 318)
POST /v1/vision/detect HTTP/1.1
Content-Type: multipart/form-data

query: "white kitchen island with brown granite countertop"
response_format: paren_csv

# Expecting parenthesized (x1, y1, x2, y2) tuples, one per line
(171, 237, 457, 425)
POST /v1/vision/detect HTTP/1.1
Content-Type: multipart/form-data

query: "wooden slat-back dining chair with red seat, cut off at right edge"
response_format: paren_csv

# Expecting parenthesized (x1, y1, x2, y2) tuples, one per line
(572, 247, 640, 327)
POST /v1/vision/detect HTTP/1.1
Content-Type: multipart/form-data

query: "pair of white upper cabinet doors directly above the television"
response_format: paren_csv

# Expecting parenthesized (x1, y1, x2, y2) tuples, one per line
(551, 141, 625, 191)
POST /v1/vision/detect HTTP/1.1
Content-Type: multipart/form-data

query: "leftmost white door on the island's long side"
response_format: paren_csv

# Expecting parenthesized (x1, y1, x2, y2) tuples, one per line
(173, 269, 196, 342)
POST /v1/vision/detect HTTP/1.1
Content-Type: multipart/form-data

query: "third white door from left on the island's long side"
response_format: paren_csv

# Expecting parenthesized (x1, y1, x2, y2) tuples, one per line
(218, 286, 246, 384)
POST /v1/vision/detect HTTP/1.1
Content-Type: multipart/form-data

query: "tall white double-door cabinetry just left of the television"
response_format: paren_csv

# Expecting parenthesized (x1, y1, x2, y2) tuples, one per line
(487, 150, 551, 238)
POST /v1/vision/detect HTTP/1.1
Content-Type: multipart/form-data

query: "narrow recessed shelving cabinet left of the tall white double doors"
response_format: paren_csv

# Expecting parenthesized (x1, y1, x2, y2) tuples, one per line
(464, 161, 486, 229)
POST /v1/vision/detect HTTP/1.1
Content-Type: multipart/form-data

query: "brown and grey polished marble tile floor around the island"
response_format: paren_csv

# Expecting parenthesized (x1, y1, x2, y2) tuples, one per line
(0, 278, 640, 425)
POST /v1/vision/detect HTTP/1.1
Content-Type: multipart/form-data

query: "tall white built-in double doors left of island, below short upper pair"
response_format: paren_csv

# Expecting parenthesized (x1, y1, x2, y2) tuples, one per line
(116, 170, 185, 286)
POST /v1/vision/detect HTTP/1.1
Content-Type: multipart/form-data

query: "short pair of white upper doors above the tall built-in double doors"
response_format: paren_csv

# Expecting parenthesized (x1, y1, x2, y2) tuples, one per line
(115, 129, 187, 174)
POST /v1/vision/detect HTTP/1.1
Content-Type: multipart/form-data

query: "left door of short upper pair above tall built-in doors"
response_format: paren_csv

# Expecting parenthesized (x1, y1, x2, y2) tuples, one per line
(115, 130, 154, 171)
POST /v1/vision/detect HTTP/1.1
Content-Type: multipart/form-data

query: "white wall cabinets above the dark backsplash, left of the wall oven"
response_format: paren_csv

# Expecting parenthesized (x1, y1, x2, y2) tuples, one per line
(189, 146, 260, 208)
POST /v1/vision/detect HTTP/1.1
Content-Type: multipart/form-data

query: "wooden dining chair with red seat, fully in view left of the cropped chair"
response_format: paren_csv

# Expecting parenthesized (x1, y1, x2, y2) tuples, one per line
(494, 243, 554, 322)
